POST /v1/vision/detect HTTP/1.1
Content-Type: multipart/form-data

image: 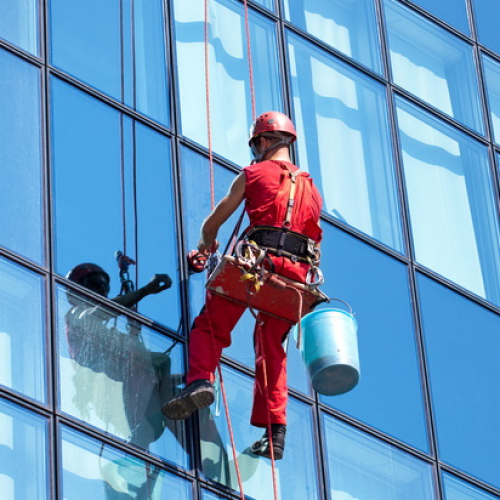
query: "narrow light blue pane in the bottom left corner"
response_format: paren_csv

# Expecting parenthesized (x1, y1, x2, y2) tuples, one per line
(0, 399, 49, 500)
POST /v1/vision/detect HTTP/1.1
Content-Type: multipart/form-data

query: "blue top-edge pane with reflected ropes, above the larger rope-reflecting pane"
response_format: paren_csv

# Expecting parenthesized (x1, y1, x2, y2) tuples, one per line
(50, 0, 170, 126)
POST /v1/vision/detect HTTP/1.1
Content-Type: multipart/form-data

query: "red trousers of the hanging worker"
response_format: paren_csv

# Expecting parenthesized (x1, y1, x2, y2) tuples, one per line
(187, 256, 309, 427)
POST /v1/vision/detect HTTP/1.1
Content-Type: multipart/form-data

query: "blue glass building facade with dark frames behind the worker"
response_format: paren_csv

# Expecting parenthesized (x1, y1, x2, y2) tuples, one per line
(0, 0, 500, 500)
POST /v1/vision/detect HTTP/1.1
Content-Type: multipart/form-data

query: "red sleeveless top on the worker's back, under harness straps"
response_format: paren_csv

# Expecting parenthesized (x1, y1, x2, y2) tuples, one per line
(243, 160, 323, 242)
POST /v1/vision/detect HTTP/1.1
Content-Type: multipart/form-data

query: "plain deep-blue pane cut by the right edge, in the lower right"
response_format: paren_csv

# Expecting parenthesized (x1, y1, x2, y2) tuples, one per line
(418, 275, 500, 488)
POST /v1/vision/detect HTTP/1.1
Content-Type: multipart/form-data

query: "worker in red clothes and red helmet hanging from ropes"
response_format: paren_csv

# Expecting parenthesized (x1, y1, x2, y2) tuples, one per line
(163, 112, 322, 459)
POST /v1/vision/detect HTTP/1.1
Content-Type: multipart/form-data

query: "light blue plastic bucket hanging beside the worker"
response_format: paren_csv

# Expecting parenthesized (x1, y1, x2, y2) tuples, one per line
(299, 309, 359, 396)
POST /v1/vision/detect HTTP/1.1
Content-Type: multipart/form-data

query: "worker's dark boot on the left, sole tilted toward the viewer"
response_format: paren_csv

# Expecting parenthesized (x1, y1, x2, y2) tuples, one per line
(161, 379, 215, 420)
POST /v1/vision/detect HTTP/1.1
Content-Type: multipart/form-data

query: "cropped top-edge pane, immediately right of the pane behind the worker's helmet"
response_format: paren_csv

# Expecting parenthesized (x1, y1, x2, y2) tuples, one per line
(283, 0, 382, 73)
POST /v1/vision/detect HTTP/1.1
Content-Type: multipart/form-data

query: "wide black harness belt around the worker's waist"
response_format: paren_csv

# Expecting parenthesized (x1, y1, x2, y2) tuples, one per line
(246, 226, 315, 262)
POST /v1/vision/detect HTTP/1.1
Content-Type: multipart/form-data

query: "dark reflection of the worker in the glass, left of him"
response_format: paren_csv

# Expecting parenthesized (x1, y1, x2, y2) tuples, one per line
(65, 263, 173, 448)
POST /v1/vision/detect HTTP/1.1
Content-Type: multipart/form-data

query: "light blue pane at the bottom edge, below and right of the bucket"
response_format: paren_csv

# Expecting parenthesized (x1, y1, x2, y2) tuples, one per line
(323, 415, 436, 500)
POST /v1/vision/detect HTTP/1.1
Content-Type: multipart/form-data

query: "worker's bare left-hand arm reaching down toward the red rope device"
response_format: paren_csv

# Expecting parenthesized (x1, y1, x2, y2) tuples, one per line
(198, 172, 245, 253)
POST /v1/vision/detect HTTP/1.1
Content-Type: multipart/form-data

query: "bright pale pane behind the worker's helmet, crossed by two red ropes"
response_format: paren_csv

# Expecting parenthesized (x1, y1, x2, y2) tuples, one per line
(173, 0, 283, 165)
